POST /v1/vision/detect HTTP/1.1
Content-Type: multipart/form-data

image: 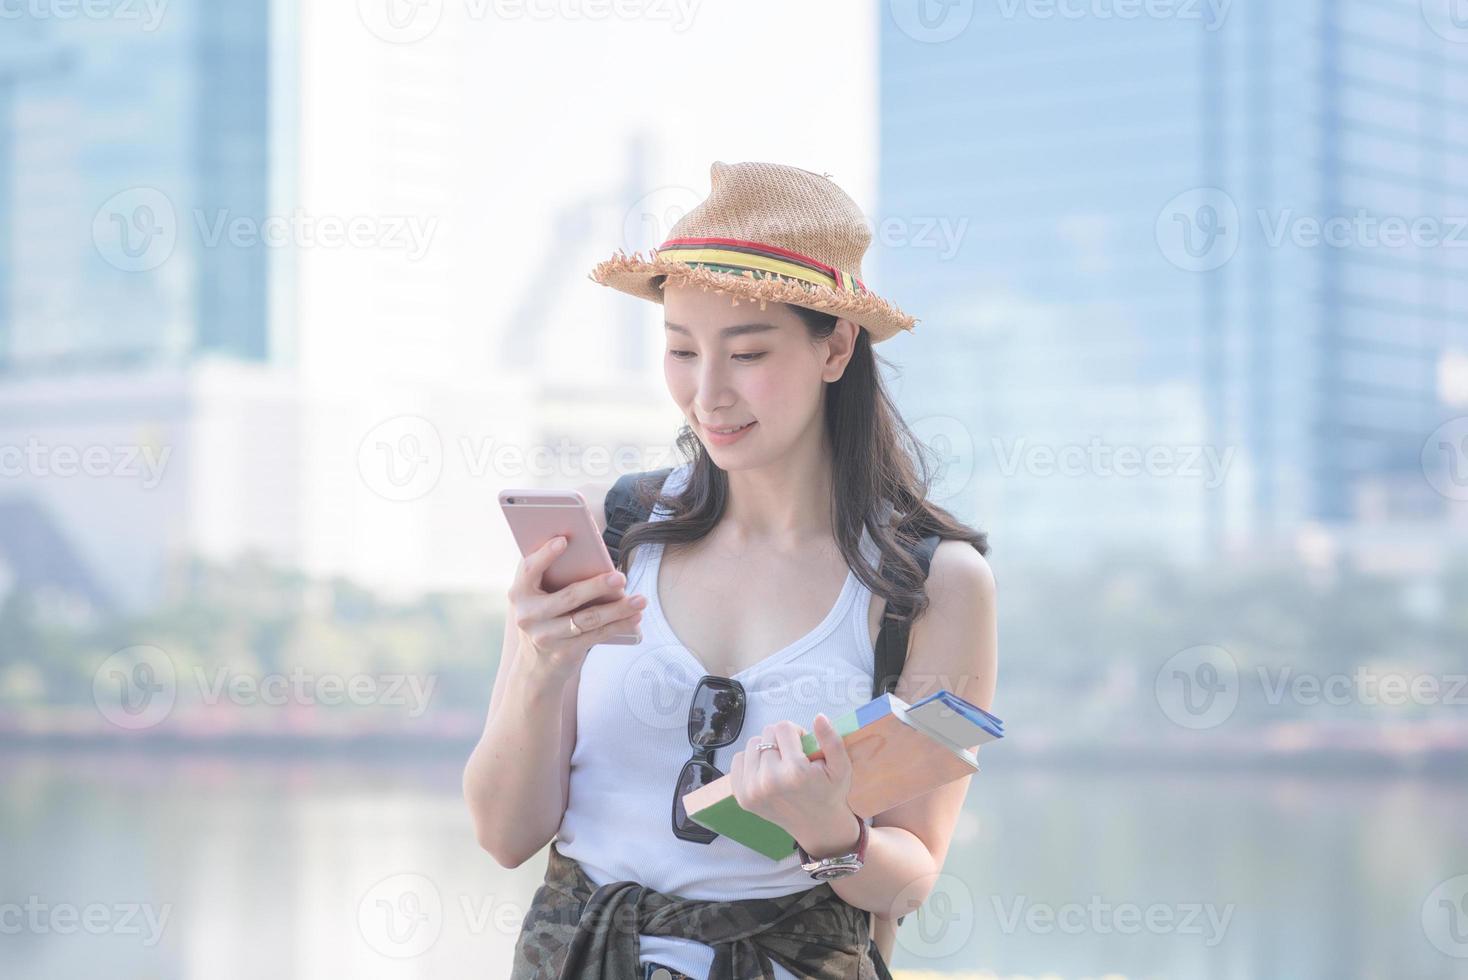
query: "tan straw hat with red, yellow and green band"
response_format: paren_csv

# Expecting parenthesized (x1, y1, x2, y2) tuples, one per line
(590, 161, 918, 343)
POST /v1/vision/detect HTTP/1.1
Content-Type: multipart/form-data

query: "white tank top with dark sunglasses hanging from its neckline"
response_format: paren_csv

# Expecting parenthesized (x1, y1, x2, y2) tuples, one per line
(551, 464, 879, 980)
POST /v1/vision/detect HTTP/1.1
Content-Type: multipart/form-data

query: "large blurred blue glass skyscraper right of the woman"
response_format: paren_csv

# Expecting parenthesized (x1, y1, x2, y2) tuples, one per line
(881, 0, 1468, 559)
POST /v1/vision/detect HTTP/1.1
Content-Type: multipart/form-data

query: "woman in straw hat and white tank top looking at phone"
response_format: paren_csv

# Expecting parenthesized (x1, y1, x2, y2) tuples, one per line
(464, 163, 997, 980)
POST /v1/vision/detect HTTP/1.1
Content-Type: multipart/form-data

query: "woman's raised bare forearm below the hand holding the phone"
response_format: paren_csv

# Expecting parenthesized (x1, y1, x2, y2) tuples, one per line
(464, 657, 567, 867)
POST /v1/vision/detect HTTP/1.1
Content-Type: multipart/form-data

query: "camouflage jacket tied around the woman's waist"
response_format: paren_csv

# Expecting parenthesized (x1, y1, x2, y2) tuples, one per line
(511, 844, 890, 980)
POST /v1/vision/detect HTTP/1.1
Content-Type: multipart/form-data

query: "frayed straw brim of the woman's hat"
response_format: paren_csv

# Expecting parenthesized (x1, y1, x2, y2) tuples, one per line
(587, 251, 918, 343)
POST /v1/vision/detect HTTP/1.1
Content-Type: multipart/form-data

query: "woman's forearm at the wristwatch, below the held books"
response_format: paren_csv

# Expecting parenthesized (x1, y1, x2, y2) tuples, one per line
(796, 811, 940, 918)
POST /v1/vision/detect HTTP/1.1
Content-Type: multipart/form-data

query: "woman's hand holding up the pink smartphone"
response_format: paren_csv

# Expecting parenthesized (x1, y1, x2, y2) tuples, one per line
(509, 537, 647, 678)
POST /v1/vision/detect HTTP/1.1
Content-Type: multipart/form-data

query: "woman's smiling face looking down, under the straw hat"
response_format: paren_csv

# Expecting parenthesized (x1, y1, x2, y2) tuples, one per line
(664, 282, 859, 469)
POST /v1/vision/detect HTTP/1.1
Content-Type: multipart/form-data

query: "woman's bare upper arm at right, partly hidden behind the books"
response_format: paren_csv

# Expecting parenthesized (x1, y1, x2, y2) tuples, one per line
(872, 540, 998, 869)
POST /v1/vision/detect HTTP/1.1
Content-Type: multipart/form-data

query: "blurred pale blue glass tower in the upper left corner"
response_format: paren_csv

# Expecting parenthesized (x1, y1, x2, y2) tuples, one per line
(0, 0, 278, 374)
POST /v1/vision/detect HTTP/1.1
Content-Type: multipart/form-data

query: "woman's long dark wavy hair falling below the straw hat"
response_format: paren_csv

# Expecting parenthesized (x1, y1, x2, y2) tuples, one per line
(619, 275, 989, 618)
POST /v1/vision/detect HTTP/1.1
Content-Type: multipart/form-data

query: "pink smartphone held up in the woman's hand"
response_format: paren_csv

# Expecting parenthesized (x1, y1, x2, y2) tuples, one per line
(499, 490, 642, 644)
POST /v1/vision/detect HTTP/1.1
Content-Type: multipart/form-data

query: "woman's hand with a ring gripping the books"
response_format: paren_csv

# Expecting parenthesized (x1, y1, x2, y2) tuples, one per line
(730, 714, 851, 841)
